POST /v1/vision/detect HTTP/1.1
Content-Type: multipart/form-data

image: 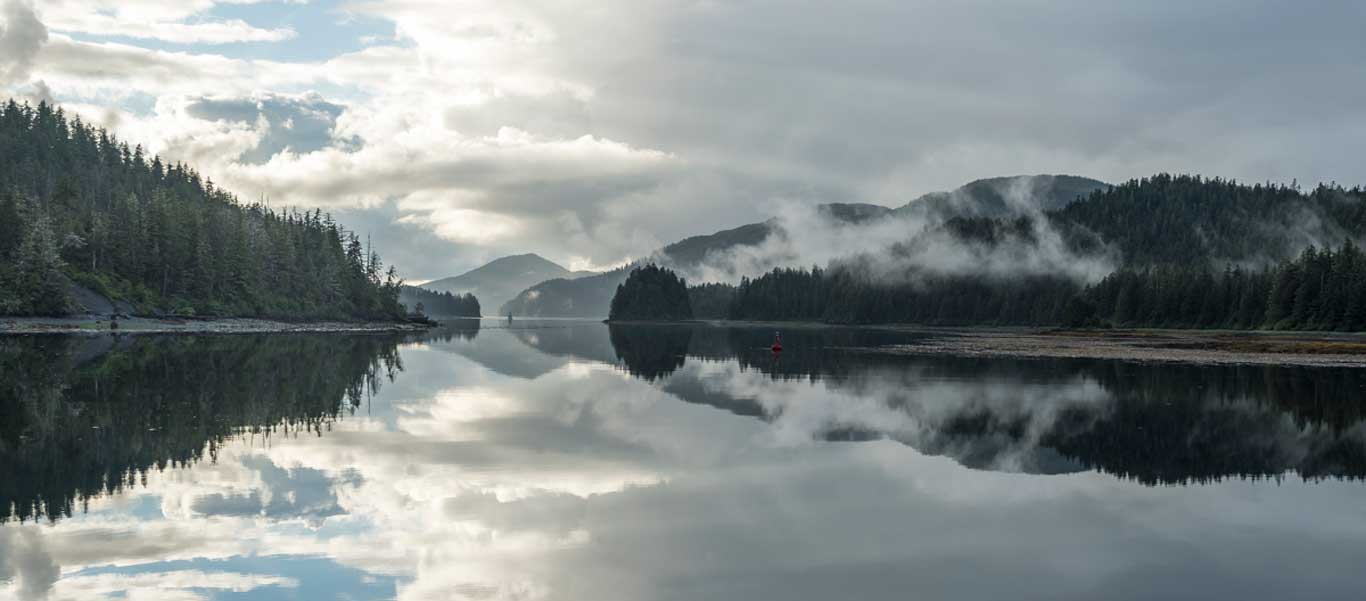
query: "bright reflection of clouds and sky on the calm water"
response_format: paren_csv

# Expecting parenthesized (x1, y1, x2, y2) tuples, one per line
(0, 325, 1366, 600)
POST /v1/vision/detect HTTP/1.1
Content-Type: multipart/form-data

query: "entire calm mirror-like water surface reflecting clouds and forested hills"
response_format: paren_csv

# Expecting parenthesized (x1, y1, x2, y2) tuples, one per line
(0, 321, 1366, 600)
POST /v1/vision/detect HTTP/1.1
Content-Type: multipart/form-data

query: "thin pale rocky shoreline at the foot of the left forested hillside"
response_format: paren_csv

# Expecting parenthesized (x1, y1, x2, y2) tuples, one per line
(0, 316, 428, 337)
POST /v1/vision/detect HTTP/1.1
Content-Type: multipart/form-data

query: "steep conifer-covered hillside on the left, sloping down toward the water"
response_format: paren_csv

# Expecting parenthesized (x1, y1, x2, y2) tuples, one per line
(0, 101, 403, 320)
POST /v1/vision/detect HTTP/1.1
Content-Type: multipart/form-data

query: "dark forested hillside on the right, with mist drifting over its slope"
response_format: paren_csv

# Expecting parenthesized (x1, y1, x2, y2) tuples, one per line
(642, 175, 1366, 331)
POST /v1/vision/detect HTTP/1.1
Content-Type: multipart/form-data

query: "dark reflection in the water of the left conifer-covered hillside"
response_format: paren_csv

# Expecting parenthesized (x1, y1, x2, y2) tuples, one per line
(0, 335, 402, 522)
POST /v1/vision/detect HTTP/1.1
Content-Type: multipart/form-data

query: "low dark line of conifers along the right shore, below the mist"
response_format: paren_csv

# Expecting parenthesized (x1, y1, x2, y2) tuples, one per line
(688, 240, 1366, 332)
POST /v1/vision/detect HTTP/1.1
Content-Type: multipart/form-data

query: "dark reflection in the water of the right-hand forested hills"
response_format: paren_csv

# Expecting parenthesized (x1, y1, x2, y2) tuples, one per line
(611, 325, 1366, 485)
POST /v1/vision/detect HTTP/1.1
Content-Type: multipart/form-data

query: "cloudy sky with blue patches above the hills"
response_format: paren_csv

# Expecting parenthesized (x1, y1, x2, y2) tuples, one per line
(0, 0, 1366, 281)
